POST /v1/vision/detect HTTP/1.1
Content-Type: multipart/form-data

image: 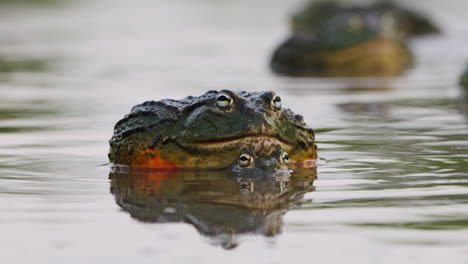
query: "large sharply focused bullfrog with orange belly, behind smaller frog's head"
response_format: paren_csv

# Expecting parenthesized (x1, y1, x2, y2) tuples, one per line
(109, 90, 317, 169)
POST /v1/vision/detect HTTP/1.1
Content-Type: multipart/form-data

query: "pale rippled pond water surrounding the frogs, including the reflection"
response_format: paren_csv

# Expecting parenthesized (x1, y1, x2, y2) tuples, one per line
(0, 0, 468, 263)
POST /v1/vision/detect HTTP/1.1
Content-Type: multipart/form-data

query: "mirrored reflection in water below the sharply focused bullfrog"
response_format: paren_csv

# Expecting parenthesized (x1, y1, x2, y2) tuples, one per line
(109, 167, 317, 249)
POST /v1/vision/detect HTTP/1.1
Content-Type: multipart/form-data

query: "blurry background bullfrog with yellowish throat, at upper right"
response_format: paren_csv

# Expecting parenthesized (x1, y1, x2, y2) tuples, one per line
(270, 3, 426, 77)
